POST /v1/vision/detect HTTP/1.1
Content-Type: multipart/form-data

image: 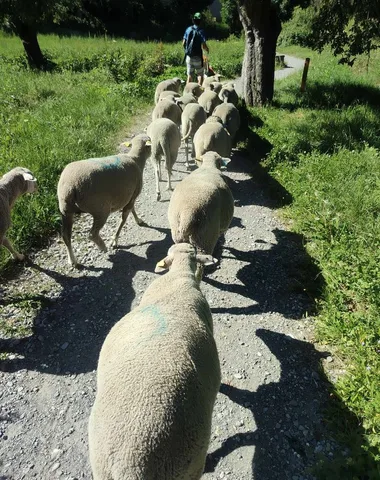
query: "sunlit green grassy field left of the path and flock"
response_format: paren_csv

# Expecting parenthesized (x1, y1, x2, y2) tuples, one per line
(0, 34, 244, 270)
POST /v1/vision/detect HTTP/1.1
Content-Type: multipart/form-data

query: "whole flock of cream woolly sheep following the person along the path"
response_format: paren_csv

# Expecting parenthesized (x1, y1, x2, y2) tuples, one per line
(0, 76, 240, 480)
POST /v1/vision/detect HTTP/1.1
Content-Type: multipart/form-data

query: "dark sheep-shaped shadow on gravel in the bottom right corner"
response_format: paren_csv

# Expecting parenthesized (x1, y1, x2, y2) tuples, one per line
(205, 329, 375, 480)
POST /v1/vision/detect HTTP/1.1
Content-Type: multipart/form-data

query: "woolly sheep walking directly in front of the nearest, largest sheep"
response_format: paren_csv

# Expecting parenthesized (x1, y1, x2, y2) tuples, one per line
(168, 152, 234, 276)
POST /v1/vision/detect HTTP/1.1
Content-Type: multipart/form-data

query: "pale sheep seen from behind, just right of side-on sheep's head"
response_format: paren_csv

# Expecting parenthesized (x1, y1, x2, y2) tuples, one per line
(147, 118, 181, 200)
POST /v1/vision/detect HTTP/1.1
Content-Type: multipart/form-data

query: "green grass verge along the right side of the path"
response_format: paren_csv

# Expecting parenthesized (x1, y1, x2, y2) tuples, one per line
(246, 47, 380, 479)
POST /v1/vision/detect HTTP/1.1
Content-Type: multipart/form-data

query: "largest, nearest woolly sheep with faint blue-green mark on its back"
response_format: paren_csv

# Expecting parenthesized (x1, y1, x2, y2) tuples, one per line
(88, 244, 221, 480)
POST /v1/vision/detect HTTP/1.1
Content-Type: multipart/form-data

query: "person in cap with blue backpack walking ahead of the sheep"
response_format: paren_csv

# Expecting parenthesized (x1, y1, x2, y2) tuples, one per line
(182, 13, 209, 85)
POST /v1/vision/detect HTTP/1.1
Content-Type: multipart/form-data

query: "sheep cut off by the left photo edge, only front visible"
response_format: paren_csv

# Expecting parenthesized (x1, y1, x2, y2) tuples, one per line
(0, 167, 37, 261)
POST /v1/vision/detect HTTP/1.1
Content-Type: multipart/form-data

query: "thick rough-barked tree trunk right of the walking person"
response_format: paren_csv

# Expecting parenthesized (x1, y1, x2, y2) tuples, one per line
(237, 0, 281, 106)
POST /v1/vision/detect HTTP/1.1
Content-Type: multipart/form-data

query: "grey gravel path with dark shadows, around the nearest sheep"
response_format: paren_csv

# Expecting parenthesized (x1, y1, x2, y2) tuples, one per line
(0, 64, 335, 480)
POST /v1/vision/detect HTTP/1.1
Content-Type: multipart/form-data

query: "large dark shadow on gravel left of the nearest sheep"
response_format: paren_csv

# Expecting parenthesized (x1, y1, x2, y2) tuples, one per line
(0, 228, 168, 375)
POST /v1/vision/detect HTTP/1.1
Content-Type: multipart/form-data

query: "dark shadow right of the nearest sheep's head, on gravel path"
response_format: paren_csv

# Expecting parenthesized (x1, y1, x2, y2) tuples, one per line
(204, 229, 324, 318)
